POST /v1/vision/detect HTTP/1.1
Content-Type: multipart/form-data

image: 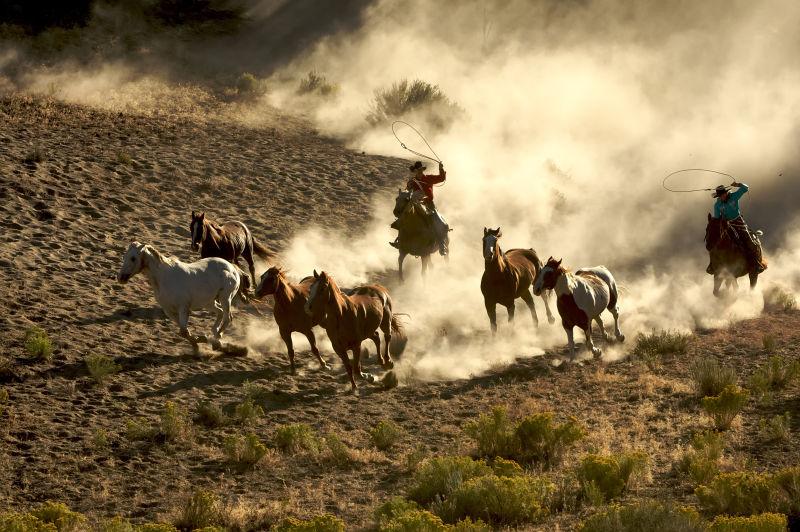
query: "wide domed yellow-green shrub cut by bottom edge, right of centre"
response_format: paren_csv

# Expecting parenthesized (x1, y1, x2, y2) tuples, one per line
(578, 501, 705, 532)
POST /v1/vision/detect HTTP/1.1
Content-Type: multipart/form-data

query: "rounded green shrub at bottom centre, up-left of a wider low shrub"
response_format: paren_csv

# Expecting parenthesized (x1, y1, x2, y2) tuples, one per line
(408, 456, 492, 504)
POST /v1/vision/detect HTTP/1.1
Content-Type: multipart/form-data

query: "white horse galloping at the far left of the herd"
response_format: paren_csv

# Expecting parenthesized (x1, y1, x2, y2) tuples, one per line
(117, 242, 242, 352)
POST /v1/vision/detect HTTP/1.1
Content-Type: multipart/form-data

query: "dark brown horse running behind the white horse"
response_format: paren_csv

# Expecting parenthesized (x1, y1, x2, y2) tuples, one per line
(189, 211, 270, 286)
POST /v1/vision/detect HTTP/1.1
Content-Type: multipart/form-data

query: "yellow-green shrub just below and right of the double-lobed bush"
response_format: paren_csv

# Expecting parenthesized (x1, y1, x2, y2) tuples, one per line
(577, 451, 650, 500)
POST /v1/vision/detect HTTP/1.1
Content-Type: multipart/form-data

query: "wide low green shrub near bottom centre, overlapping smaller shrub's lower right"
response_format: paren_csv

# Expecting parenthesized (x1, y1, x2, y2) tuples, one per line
(433, 475, 554, 525)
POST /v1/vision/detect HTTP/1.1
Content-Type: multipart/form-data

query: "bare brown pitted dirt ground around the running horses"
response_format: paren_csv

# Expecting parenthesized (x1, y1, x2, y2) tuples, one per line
(0, 96, 800, 529)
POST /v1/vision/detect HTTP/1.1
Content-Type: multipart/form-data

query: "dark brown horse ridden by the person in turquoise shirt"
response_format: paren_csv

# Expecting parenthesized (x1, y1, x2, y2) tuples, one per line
(705, 214, 763, 297)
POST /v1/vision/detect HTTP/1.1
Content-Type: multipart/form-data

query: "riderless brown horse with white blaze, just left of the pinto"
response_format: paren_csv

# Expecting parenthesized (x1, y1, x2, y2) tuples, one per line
(481, 227, 555, 335)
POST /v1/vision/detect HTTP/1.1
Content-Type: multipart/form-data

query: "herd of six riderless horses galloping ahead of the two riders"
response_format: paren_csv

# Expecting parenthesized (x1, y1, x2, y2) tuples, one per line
(117, 201, 625, 391)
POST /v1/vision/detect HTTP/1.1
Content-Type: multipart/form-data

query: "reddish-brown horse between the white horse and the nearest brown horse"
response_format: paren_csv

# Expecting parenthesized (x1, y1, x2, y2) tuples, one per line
(256, 266, 330, 373)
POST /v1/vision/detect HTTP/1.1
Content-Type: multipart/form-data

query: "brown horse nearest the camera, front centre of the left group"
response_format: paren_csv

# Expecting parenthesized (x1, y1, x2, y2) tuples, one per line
(305, 270, 403, 392)
